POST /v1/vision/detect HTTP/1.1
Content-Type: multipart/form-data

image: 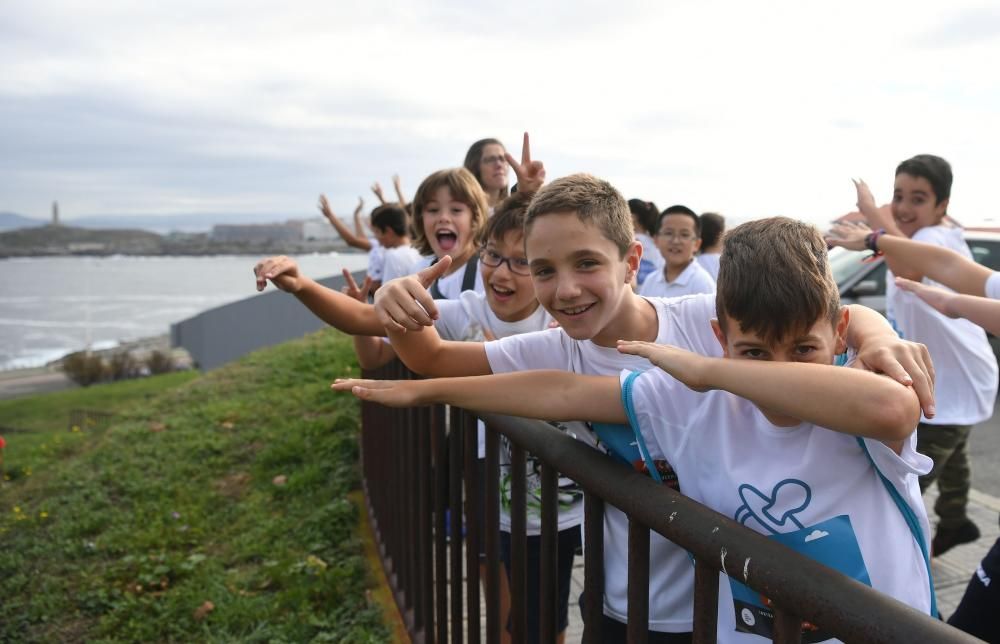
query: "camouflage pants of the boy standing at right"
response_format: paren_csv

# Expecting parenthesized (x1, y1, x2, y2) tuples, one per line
(917, 423, 972, 529)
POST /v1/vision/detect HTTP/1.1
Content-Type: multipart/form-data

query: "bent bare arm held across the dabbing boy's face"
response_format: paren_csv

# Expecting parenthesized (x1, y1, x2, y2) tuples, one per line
(618, 341, 920, 452)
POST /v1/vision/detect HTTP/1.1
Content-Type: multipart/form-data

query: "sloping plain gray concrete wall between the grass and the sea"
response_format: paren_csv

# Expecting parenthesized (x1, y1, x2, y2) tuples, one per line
(170, 271, 365, 371)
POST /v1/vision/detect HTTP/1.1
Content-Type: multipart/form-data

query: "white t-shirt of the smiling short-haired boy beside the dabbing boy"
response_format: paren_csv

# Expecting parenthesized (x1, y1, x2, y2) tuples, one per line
(486, 295, 722, 633)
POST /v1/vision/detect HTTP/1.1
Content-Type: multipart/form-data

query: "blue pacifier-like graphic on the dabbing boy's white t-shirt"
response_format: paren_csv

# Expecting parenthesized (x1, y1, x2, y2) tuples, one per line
(729, 479, 872, 642)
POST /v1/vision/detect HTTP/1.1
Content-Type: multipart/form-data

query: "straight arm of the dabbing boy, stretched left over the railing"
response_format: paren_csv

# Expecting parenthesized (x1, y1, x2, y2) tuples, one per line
(331, 370, 628, 423)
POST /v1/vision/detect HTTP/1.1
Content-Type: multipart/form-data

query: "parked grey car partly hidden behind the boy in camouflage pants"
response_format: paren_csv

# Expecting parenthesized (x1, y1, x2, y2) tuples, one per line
(830, 231, 1000, 360)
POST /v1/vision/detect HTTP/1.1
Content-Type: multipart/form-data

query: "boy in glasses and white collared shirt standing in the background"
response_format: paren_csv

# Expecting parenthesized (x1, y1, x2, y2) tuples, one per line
(639, 205, 715, 297)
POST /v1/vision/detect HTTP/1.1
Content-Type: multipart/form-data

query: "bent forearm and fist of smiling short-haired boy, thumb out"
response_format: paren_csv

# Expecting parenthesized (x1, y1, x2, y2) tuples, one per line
(375, 255, 492, 377)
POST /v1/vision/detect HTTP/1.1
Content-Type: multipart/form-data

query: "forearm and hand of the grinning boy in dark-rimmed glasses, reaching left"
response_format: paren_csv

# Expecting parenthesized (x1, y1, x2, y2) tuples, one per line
(253, 255, 385, 335)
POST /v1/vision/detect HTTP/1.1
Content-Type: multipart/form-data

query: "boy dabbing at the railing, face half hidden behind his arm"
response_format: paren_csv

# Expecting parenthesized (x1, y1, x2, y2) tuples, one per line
(334, 219, 936, 642)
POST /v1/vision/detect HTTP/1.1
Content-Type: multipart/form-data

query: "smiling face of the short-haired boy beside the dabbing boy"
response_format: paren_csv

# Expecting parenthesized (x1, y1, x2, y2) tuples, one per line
(525, 212, 641, 347)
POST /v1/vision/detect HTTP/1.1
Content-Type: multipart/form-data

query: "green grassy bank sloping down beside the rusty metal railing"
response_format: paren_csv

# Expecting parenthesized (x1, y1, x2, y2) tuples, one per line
(0, 332, 388, 642)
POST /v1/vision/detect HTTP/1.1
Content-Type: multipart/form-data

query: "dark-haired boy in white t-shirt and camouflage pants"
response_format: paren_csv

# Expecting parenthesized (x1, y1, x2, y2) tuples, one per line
(856, 154, 998, 556)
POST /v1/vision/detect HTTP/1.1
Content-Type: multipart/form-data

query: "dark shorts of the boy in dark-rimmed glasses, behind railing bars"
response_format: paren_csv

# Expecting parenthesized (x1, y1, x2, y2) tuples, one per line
(500, 526, 582, 644)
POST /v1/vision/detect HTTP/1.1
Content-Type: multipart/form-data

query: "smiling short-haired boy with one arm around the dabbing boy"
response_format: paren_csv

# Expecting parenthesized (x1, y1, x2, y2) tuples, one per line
(376, 174, 933, 643)
